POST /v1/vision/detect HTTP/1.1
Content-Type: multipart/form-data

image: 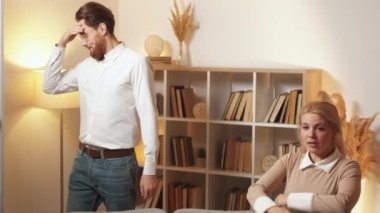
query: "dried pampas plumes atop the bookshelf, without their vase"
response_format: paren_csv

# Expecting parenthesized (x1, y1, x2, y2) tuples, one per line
(170, 0, 193, 43)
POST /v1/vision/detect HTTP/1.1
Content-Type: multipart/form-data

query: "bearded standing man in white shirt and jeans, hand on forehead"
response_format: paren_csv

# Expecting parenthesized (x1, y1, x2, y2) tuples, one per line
(43, 2, 158, 212)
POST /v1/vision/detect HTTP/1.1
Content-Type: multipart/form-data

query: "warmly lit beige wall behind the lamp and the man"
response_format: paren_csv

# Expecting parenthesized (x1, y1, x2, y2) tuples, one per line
(2, 0, 118, 213)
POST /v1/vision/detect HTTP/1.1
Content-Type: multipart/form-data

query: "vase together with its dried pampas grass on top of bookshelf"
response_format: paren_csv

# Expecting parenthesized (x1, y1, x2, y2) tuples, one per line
(170, 0, 193, 65)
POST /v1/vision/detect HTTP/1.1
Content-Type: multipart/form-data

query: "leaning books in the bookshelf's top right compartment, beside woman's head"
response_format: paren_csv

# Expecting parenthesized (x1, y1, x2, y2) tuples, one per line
(264, 89, 302, 124)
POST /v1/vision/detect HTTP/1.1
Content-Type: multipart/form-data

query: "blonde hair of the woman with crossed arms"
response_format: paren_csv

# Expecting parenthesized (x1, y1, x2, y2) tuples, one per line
(298, 101, 346, 156)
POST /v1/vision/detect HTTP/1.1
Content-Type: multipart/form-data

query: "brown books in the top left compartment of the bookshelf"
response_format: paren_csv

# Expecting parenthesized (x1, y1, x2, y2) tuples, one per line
(170, 85, 196, 118)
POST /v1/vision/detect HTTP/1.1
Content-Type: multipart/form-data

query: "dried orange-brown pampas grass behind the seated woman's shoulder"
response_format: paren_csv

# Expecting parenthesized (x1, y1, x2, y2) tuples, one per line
(318, 91, 380, 181)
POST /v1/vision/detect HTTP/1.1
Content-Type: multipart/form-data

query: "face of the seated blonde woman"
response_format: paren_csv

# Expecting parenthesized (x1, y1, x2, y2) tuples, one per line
(300, 113, 336, 162)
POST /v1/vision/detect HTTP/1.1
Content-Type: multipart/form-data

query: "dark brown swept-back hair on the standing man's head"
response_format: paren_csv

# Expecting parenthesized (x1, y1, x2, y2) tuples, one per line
(75, 2, 115, 35)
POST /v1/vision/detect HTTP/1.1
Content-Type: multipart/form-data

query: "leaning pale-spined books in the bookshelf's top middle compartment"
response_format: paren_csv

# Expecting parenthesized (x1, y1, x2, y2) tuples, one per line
(222, 90, 253, 121)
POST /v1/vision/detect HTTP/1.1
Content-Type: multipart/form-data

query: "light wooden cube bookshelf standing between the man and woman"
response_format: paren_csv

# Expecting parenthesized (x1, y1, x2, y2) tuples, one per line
(153, 64, 322, 211)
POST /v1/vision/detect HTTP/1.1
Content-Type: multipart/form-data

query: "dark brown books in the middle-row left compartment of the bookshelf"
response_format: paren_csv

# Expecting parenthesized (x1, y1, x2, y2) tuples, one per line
(171, 136, 194, 166)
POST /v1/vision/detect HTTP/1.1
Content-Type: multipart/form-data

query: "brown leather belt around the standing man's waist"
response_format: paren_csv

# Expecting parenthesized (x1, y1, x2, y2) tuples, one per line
(79, 143, 135, 158)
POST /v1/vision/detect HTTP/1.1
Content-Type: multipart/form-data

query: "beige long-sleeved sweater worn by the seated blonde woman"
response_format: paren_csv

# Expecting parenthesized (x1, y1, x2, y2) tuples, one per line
(247, 153, 361, 212)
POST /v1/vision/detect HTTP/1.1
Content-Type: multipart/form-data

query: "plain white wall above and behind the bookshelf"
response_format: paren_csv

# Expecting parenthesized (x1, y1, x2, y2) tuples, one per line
(119, 0, 380, 212)
